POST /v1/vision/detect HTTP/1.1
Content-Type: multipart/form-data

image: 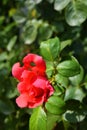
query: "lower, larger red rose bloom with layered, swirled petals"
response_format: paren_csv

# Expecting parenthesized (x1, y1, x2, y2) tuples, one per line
(16, 78, 53, 108)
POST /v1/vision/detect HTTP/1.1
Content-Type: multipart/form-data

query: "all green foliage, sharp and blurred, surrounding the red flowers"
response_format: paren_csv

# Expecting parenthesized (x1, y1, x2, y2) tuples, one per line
(0, 0, 87, 130)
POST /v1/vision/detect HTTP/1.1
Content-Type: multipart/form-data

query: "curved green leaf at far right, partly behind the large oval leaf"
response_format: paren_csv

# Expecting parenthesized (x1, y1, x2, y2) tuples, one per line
(69, 66, 84, 86)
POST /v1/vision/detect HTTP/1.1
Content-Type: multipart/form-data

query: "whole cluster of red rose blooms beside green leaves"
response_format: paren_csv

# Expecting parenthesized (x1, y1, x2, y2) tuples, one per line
(12, 53, 54, 108)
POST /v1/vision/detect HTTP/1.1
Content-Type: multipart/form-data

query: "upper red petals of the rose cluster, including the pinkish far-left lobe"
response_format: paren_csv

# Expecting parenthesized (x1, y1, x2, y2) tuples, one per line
(12, 53, 46, 81)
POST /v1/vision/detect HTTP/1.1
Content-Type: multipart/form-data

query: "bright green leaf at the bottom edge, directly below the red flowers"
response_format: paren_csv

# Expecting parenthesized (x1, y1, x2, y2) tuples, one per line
(29, 107, 47, 130)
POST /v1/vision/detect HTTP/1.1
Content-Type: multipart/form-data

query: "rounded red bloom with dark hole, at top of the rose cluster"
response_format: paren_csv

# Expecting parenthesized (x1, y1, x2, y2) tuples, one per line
(23, 54, 46, 75)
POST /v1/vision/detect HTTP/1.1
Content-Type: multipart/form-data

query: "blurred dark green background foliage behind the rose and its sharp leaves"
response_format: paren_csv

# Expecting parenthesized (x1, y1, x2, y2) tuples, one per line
(0, 0, 87, 130)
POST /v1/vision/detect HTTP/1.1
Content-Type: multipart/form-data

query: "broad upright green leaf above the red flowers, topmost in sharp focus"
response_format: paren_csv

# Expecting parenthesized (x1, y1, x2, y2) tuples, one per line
(40, 37, 60, 61)
